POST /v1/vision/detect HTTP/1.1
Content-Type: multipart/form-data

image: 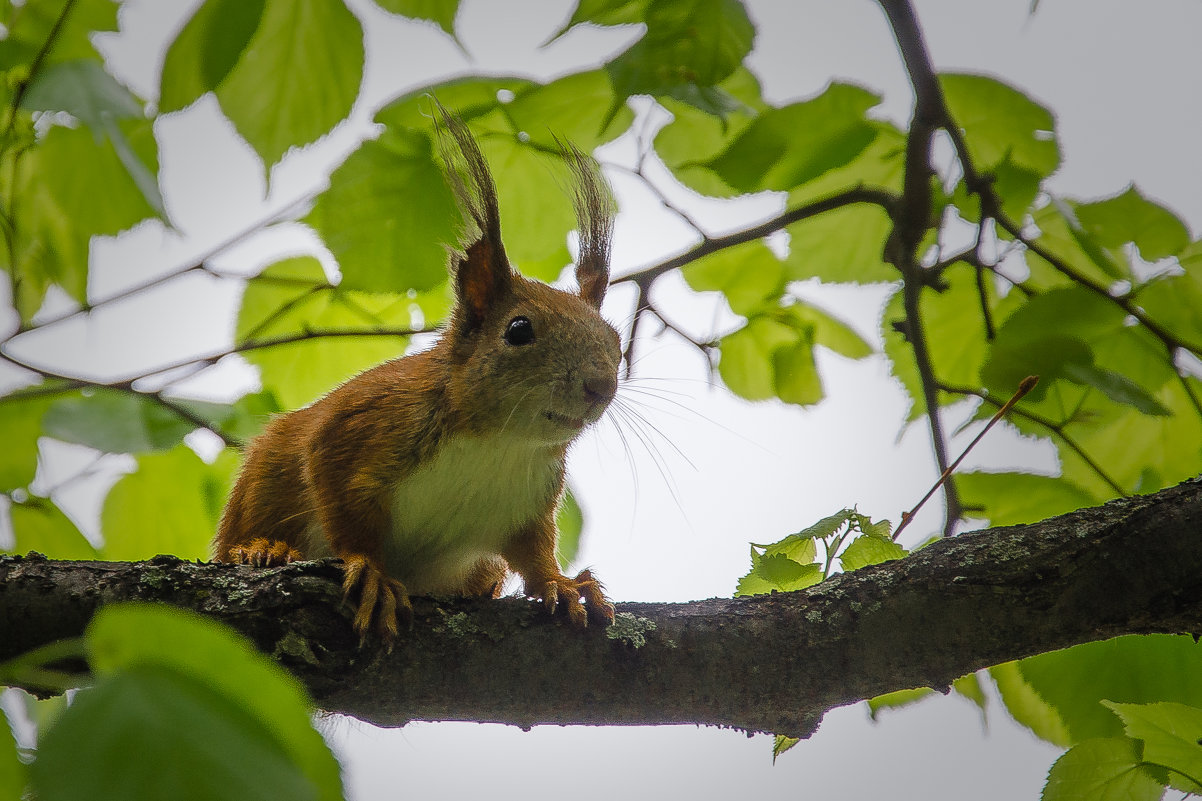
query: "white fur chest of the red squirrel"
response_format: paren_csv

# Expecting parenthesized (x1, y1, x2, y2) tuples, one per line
(385, 434, 563, 593)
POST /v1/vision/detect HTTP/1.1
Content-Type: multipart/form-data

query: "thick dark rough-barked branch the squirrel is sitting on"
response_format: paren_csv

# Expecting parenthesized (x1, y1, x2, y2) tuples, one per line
(0, 480, 1202, 735)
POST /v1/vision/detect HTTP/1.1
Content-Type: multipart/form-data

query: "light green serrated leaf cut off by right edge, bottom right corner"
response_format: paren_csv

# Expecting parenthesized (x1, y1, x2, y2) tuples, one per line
(1102, 701, 1202, 785)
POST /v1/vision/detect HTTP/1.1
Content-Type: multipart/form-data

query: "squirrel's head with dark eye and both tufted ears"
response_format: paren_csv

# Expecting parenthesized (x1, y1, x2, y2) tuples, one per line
(438, 106, 621, 445)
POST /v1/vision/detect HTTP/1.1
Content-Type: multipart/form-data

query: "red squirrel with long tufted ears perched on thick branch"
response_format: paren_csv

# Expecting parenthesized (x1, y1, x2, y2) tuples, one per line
(214, 107, 621, 641)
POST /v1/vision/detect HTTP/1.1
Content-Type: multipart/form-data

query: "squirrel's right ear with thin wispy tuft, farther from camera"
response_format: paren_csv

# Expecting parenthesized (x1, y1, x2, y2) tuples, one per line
(560, 142, 617, 309)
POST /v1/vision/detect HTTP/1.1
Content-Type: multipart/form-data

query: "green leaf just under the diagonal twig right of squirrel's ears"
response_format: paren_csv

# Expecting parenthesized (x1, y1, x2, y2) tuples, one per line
(680, 239, 785, 316)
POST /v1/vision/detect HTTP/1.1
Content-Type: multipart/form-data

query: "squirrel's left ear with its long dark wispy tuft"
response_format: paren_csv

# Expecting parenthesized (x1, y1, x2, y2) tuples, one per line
(433, 99, 513, 330)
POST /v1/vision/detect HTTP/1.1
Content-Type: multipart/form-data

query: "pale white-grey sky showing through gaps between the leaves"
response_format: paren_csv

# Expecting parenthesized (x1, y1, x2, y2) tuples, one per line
(0, 0, 1202, 801)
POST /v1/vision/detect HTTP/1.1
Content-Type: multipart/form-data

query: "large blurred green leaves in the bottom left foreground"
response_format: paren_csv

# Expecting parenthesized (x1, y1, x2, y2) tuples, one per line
(0, 604, 343, 801)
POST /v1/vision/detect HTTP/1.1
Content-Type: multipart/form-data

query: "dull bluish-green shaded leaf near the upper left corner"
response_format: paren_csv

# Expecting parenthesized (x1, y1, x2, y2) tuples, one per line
(20, 59, 143, 126)
